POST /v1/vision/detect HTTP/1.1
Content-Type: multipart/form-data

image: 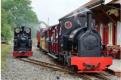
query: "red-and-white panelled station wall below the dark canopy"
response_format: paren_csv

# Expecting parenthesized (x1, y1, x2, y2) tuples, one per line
(97, 22, 121, 46)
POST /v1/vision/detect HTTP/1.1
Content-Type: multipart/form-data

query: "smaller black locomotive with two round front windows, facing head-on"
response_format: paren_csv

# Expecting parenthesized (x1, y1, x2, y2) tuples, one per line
(13, 26, 32, 57)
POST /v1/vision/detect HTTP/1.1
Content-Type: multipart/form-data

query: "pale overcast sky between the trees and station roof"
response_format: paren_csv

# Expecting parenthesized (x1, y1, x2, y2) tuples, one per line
(31, 0, 90, 25)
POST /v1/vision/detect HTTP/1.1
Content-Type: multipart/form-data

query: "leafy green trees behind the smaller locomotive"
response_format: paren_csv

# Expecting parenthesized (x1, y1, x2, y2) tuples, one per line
(1, 0, 39, 40)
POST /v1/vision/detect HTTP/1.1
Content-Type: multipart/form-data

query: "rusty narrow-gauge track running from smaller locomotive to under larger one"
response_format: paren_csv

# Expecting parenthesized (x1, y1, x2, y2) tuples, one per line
(18, 58, 117, 80)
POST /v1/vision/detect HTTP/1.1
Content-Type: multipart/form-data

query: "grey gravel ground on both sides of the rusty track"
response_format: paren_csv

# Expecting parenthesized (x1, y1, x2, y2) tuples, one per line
(1, 47, 82, 80)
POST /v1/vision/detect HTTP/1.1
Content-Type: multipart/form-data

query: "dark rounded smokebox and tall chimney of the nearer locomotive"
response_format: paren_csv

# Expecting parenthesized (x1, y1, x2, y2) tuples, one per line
(77, 11, 101, 57)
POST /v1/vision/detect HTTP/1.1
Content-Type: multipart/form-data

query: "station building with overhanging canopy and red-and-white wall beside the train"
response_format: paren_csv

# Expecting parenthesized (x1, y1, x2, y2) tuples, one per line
(64, 0, 121, 58)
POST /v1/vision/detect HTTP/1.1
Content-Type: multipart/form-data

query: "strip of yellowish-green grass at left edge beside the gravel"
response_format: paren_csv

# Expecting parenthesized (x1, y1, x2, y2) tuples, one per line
(1, 44, 11, 69)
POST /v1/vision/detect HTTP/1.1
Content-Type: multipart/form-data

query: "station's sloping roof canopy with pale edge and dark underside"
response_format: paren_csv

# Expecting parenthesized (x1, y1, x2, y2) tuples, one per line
(61, 0, 121, 24)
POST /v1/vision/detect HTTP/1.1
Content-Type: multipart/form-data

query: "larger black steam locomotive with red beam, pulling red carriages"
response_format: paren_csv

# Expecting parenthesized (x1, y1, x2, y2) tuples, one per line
(37, 11, 112, 72)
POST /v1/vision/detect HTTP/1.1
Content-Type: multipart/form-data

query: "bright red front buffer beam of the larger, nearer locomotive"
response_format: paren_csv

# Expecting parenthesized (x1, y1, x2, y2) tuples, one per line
(71, 56, 112, 72)
